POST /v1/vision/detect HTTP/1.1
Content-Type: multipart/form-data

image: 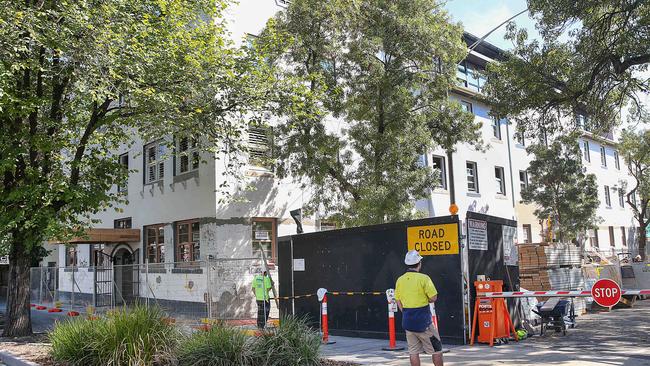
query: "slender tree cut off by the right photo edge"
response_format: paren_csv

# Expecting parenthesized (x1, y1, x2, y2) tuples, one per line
(619, 110, 650, 259)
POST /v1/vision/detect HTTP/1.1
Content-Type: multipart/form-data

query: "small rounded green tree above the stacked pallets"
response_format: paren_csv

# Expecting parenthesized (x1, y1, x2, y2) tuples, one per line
(521, 134, 600, 241)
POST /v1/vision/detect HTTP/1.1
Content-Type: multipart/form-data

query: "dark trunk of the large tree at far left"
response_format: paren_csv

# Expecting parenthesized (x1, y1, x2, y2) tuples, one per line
(2, 243, 32, 337)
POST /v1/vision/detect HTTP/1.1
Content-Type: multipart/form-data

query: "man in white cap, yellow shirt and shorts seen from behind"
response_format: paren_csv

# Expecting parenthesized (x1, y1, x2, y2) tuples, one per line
(395, 250, 443, 366)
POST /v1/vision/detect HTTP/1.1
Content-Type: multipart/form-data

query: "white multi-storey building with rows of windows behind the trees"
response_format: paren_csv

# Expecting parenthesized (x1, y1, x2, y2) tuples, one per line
(43, 0, 635, 274)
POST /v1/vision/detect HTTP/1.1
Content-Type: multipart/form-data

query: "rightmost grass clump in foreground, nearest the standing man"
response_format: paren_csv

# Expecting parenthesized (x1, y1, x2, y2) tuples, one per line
(253, 317, 321, 366)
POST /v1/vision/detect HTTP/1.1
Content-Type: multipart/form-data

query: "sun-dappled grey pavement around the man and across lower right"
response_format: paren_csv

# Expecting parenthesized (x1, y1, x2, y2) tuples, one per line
(323, 300, 650, 366)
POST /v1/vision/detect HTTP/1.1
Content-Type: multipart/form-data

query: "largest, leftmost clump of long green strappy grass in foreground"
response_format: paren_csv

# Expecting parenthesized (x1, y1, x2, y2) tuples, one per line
(50, 306, 180, 366)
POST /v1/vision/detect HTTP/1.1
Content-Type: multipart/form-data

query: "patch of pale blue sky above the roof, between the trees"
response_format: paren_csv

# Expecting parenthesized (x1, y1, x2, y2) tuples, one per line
(445, 0, 535, 49)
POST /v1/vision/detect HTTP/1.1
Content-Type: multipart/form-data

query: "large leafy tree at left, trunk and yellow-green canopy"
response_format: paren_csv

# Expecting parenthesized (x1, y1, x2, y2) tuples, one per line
(0, 0, 277, 336)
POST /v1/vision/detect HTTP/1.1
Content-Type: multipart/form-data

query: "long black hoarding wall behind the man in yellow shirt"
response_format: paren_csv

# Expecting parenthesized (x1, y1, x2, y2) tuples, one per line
(278, 216, 464, 343)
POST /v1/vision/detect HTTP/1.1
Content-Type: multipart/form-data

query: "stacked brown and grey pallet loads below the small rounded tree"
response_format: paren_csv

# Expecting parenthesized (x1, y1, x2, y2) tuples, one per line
(518, 243, 586, 314)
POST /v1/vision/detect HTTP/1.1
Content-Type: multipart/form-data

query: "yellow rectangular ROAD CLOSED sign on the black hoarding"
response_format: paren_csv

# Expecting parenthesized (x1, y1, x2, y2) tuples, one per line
(406, 224, 459, 255)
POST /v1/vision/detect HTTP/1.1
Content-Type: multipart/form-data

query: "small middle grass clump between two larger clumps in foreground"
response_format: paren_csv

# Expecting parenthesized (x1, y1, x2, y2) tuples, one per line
(178, 324, 254, 366)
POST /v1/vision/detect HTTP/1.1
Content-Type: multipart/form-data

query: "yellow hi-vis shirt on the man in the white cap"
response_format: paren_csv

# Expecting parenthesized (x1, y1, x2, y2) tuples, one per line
(395, 272, 438, 309)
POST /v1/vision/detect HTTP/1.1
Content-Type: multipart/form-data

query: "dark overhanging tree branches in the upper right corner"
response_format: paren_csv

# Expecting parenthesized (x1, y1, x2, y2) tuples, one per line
(484, 0, 650, 135)
